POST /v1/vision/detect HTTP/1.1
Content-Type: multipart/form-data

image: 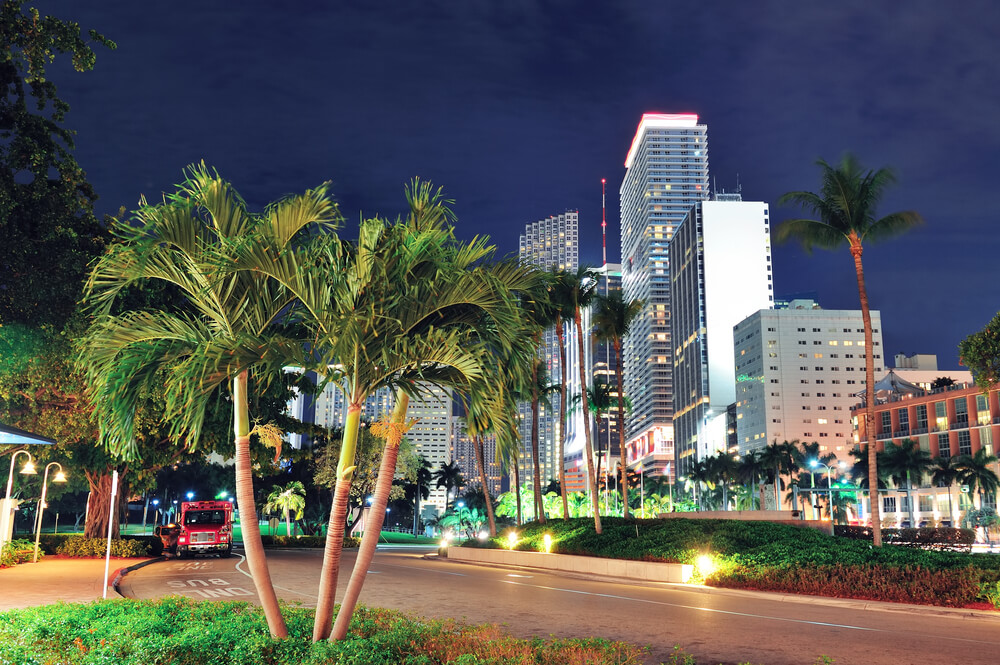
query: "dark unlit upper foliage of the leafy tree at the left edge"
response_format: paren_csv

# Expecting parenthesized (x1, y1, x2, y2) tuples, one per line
(0, 0, 116, 330)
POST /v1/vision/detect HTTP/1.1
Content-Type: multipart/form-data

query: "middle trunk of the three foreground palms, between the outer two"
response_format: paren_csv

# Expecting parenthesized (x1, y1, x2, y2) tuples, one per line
(313, 396, 365, 642)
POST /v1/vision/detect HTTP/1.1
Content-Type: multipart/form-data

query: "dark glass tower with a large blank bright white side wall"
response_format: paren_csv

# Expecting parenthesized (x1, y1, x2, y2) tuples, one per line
(670, 195, 774, 476)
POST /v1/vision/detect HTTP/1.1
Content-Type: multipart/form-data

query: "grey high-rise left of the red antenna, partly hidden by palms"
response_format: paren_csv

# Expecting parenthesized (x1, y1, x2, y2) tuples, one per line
(518, 210, 582, 487)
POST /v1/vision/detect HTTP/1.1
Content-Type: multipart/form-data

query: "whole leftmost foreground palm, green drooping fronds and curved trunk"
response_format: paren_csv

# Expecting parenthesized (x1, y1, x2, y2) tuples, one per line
(75, 164, 340, 637)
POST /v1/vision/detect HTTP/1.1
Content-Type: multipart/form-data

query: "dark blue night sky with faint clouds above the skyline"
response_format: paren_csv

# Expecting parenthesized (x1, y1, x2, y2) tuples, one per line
(50, 0, 1000, 369)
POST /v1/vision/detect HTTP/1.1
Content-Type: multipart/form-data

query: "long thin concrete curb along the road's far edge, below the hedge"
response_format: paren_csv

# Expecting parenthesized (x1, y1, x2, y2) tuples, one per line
(436, 554, 1000, 623)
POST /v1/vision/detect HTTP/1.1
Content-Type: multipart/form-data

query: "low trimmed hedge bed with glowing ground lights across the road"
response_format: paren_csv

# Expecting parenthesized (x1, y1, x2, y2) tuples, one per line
(482, 517, 1000, 607)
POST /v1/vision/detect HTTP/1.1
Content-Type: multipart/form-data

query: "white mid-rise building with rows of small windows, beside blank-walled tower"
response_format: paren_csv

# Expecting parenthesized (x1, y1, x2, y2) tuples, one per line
(733, 300, 885, 461)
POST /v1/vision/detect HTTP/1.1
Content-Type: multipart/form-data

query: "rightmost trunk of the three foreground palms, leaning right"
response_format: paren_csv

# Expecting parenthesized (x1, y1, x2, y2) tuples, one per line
(330, 392, 410, 642)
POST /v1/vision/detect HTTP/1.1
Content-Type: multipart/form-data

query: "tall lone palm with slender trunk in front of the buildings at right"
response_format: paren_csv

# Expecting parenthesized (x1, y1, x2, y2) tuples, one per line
(775, 154, 923, 547)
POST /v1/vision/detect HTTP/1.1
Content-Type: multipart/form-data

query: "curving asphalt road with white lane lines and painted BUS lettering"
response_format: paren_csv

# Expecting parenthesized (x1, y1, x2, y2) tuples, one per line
(120, 548, 1000, 665)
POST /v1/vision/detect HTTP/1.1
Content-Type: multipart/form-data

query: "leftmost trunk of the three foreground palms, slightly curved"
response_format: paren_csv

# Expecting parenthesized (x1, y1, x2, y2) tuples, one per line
(233, 370, 288, 639)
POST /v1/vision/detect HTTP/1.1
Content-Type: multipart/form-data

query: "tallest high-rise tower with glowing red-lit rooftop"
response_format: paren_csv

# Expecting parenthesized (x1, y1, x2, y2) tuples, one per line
(621, 113, 709, 475)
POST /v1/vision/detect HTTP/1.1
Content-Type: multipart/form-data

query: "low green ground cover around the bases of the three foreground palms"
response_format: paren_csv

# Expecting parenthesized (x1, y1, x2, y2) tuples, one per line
(0, 596, 646, 665)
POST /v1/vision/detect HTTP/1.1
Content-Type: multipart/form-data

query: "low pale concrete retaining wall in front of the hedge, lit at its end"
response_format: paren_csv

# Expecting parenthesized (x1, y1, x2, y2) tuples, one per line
(447, 547, 694, 583)
